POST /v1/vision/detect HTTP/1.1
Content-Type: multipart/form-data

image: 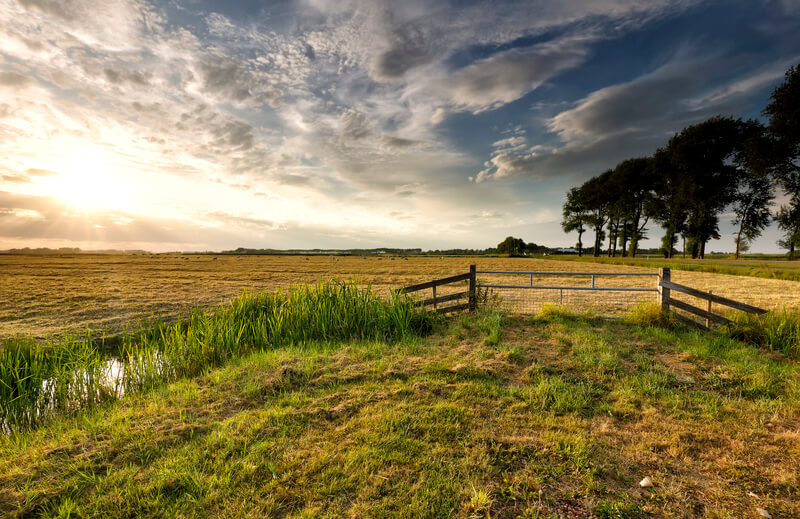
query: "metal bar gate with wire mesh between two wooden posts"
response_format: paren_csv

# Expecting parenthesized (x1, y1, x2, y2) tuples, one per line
(476, 270, 659, 317)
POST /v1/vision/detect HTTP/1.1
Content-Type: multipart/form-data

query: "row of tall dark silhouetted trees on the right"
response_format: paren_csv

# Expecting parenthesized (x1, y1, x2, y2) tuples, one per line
(561, 65, 800, 258)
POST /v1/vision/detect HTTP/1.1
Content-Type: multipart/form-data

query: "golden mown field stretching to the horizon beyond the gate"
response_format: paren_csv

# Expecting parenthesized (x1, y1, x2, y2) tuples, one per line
(0, 255, 800, 338)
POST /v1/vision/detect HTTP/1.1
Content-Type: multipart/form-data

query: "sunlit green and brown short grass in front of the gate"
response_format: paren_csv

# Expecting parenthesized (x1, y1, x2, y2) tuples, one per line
(0, 310, 800, 518)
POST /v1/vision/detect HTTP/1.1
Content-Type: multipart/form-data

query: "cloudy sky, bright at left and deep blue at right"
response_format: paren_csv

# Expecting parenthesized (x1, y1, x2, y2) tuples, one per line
(0, 0, 800, 252)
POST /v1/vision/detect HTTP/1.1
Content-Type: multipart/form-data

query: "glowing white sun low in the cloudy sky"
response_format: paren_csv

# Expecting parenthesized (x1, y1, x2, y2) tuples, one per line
(48, 151, 130, 213)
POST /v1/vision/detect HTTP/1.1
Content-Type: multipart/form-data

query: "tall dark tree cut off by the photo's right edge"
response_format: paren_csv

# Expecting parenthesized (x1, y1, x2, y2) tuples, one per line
(764, 65, 800, 259)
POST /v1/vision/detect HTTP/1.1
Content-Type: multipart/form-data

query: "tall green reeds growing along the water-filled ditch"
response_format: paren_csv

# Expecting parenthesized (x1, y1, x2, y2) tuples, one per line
(0, 280, 434, 432)
